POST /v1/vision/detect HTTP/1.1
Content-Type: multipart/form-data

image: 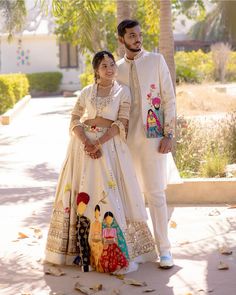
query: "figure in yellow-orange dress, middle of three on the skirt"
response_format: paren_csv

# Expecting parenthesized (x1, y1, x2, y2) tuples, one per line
(89, 205, 103, 272)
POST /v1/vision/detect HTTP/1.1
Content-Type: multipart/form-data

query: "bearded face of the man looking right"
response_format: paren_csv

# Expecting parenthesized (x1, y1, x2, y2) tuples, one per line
(120, 26, 143, 52)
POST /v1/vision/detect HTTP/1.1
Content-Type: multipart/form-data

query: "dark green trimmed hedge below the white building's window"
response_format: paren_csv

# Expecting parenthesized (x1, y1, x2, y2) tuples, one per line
(27, 72, 62, 93)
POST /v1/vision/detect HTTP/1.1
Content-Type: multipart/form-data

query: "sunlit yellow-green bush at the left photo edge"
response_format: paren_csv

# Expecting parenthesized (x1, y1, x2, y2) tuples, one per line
(0, 74, 29, 114)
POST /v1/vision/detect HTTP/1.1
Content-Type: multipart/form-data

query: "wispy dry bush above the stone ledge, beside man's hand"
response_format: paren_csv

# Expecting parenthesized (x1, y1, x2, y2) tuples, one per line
(175, 112, 236, 178)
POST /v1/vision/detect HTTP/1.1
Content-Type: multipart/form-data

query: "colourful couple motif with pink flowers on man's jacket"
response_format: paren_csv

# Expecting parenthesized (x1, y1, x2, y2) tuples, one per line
(146, 84, 163, 138)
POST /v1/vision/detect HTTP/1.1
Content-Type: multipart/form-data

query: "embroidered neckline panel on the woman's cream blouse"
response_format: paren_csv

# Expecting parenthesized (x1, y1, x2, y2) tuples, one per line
(90, 84, 114, 115)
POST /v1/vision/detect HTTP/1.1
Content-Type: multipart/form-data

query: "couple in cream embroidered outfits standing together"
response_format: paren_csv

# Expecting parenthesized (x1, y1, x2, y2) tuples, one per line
(45, 20, 178, 273)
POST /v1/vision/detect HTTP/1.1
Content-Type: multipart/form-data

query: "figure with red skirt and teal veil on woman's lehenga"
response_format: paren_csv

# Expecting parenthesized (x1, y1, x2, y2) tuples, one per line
(100, 211, 129, 272)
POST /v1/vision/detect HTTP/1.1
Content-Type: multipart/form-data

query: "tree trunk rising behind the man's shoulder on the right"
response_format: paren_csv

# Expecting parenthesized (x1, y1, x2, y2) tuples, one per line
(159, 0, 176, 89)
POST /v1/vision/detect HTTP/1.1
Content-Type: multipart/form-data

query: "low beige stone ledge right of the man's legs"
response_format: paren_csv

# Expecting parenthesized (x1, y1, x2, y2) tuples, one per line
(166, 178, 236, 204)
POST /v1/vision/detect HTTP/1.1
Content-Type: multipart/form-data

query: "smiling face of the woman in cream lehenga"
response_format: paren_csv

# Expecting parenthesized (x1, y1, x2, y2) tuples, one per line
(97, 56, 116, 81)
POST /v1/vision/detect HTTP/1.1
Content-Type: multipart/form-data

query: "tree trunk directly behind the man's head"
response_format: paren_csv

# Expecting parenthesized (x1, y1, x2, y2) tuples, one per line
(116, 0, 132, 57)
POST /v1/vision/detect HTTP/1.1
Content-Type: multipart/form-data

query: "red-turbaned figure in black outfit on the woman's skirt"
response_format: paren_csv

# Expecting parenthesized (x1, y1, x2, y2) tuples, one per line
(74, 192, 90, 272)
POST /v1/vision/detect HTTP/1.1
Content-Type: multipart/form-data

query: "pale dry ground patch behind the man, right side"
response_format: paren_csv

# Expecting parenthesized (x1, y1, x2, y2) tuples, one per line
(176, 84, 236, 116)
